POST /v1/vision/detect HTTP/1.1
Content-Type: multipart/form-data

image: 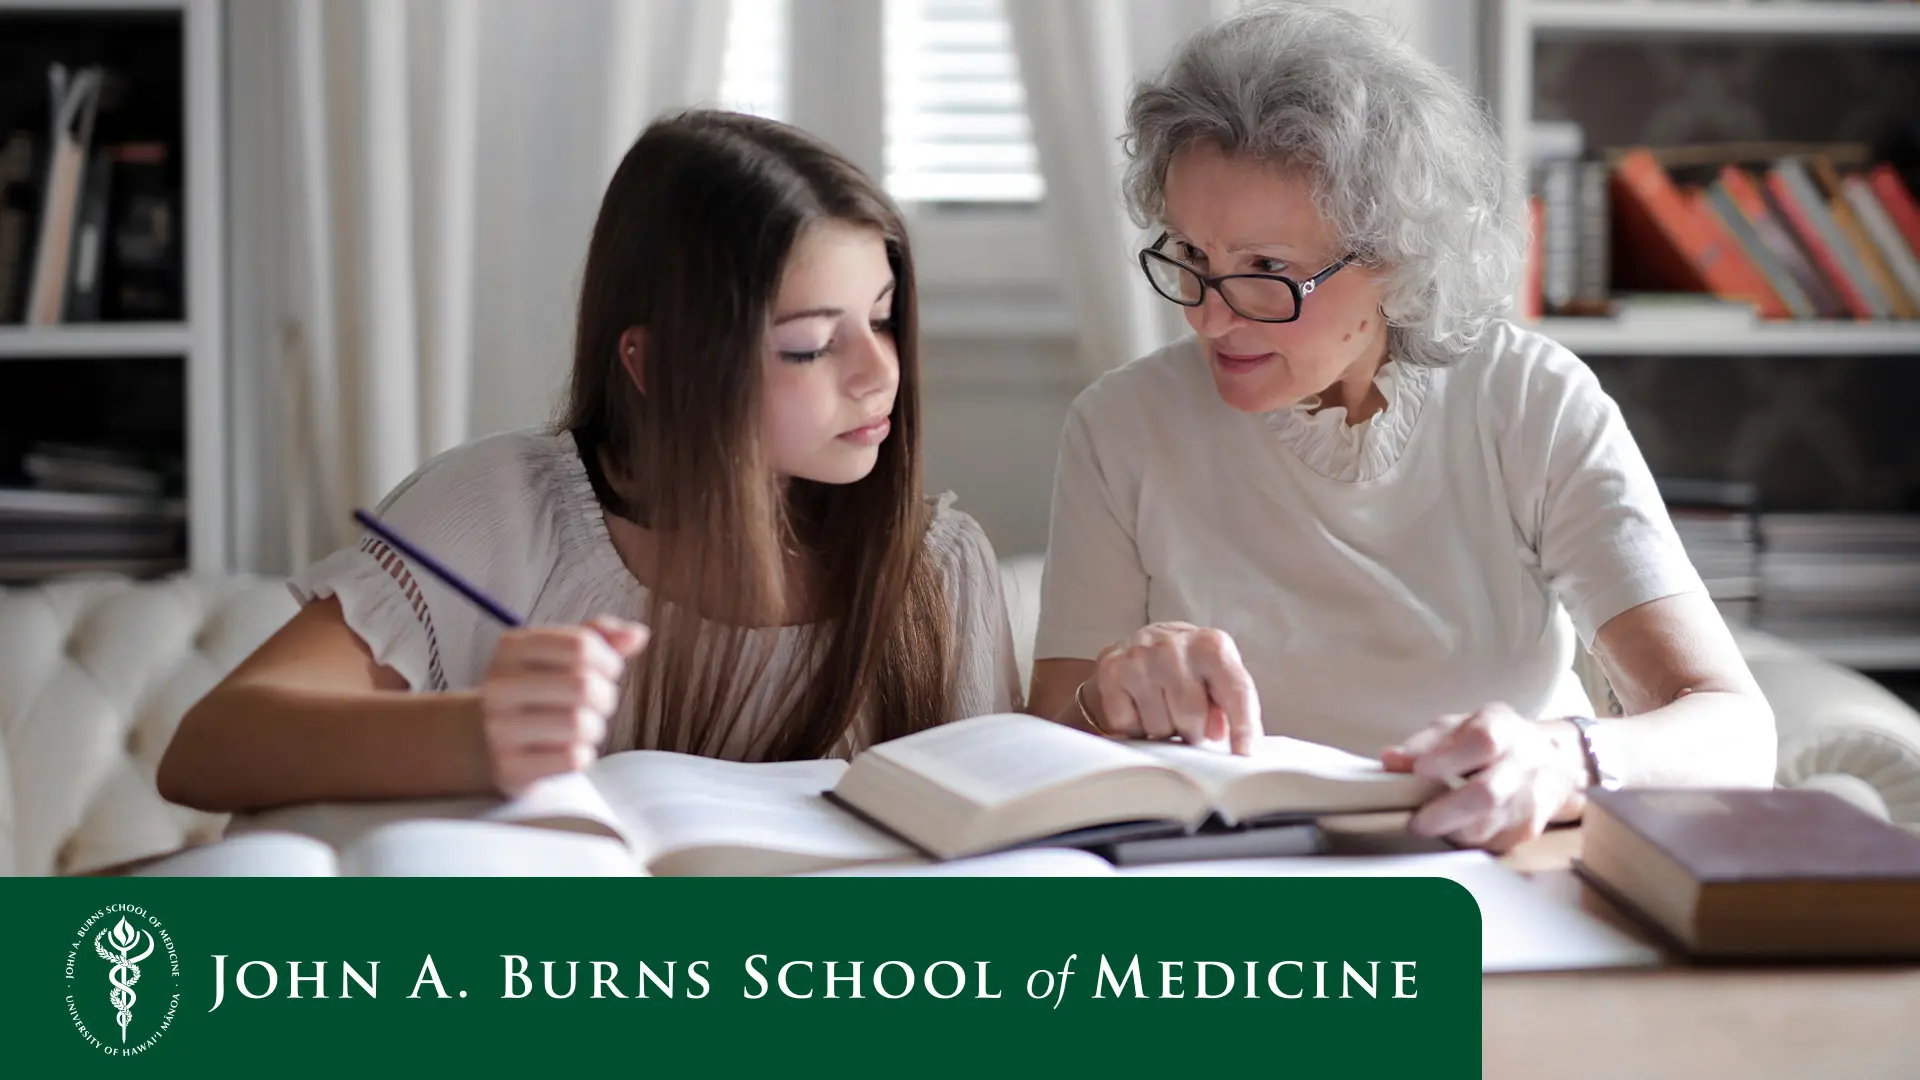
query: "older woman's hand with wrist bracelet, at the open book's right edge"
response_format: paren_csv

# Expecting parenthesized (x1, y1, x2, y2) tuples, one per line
(1380, 703, 1586, 851)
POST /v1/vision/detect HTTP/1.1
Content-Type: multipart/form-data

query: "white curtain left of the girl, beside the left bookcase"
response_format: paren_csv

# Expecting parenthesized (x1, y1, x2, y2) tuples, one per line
(228, 0, 728, 571)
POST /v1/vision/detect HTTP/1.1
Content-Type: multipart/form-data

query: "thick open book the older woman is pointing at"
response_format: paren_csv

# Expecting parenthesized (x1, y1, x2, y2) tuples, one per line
(831, 713, 1446, 859)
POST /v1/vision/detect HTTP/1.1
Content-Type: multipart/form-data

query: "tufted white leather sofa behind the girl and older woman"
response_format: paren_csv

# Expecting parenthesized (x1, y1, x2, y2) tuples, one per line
(0, 555, 1920, 874)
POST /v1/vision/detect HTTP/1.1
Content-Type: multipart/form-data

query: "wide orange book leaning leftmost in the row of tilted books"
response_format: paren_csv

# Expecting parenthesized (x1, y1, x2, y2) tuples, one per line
(1613, 150, 1786, 319)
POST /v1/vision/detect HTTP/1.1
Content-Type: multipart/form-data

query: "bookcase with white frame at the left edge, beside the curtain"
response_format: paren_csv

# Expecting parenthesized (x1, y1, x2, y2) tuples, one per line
(0, 0, 228, 571)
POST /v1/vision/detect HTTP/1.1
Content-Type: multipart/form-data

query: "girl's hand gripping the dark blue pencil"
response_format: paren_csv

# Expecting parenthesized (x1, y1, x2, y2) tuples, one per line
(480, 617, 647, 796)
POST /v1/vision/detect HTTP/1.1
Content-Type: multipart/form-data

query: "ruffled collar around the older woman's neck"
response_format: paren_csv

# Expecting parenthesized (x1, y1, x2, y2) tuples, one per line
(1260, 359, 1432, 484)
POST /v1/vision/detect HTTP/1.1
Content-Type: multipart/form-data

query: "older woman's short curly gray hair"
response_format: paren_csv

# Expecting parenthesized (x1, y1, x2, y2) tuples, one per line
(1125, 4, 1526, 365)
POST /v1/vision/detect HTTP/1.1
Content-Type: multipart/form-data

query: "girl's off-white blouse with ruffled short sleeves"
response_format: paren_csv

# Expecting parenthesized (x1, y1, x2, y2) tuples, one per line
(290, 430, 1020, 757)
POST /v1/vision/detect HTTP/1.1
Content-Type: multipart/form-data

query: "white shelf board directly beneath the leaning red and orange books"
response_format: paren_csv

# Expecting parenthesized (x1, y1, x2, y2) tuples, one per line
(1534, 319, 1920, 357)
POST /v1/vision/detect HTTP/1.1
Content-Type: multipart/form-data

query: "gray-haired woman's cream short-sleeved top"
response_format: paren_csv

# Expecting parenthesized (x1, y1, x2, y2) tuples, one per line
(1033, 323, 1703, 753)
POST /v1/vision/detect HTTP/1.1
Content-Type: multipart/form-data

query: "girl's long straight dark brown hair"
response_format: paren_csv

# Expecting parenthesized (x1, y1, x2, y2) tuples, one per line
(561, 111, 952, 759)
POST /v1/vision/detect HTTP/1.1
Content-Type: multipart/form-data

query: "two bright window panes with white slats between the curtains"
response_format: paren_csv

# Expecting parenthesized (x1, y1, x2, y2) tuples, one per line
(720, 0, 1043, 204)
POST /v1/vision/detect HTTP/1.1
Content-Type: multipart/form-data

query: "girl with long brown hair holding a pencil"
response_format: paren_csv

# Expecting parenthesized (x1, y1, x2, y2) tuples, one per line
(159, 111, 1020, 811)
